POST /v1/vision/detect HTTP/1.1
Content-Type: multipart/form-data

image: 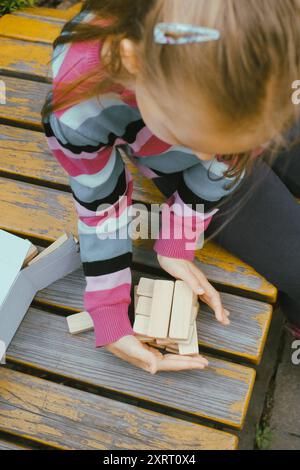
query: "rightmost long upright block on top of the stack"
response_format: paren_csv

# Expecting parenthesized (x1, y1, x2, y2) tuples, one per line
(169, 281, 197, 340)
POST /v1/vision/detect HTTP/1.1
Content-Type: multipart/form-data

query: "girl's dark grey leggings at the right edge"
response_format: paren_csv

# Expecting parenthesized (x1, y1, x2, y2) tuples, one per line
(206, 145, 300, 327)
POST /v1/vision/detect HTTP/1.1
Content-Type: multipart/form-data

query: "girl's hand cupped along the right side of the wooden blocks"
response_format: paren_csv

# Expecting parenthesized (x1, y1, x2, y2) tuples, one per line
(157, 255, 230, 326)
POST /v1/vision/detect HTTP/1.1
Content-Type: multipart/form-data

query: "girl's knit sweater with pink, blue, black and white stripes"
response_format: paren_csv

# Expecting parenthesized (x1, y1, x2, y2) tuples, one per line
(43, 13, 246, 347)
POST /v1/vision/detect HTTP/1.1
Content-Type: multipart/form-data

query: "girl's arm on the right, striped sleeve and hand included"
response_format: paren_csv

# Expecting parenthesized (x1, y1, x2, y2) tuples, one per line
(130, 148, 237, 325)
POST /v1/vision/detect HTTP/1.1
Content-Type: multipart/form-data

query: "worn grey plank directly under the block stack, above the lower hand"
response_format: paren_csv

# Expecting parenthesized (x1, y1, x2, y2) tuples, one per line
(35, 268, 272, 364)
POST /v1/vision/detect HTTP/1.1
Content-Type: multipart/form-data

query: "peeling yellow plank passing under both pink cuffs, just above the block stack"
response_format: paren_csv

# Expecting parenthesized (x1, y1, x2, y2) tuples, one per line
(0, 178, 277, 302)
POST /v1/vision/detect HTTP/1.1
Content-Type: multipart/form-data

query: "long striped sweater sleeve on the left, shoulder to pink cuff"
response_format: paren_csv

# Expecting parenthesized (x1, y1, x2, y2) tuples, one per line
(43, 89, 148, 347)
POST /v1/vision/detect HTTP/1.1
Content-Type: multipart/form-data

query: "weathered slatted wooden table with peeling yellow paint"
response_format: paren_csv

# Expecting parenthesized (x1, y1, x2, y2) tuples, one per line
(0, 6, 284, 450)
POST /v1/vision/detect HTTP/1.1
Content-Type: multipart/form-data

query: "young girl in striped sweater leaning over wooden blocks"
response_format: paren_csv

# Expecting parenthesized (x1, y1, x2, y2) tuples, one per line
(42, 0, 300, 373)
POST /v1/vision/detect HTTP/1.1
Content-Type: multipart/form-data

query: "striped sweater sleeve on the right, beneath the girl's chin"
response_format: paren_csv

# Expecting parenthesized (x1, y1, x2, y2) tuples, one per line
(129, 141, 244, 261)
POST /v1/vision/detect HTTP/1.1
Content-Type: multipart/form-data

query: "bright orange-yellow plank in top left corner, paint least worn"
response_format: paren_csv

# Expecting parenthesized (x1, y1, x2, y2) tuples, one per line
(0, 15, 63, 47)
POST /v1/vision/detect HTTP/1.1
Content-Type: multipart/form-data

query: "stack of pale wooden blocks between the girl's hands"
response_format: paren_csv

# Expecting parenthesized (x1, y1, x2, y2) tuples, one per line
(133, 278, 199, 356)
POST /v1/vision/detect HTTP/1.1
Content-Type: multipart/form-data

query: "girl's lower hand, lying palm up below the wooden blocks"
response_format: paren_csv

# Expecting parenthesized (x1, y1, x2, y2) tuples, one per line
(105, 335, 208, 374)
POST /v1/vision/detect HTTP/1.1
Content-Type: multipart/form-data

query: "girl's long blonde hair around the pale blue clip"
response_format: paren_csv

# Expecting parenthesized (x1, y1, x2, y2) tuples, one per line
(42, 0, 300, 241)
